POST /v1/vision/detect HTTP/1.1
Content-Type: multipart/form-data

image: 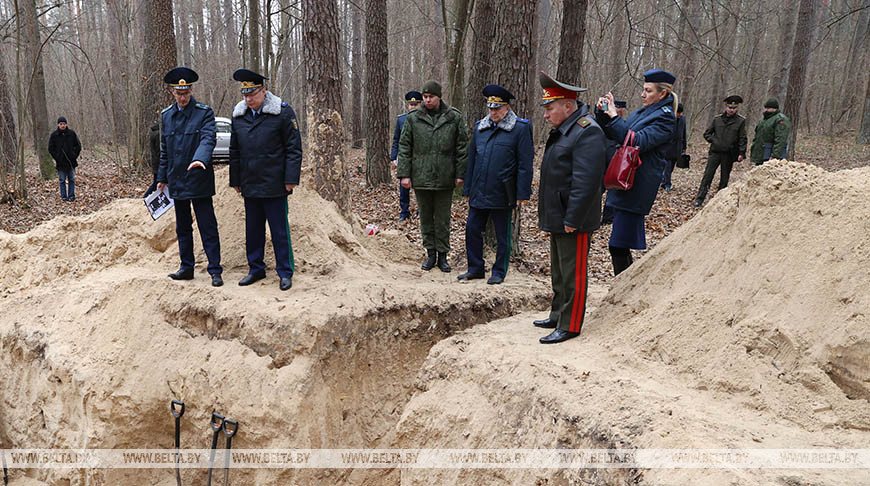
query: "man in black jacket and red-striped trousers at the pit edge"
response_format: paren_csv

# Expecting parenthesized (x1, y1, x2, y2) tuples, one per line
(534, 72, 607, 344)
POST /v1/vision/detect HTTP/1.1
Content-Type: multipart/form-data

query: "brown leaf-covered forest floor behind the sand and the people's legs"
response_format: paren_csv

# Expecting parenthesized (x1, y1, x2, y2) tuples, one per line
(0, 133, 870, 283)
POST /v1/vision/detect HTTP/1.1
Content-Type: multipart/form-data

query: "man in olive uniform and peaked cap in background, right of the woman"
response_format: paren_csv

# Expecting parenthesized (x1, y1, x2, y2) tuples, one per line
(693, 95, 746, 207)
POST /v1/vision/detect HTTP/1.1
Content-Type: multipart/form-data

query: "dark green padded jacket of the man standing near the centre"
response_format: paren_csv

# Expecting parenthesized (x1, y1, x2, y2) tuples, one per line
(396, 101, 468, 190)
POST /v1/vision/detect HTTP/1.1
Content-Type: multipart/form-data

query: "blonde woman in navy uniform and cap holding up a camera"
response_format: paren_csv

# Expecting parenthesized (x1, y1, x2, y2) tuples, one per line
(596, 69, 677, 275)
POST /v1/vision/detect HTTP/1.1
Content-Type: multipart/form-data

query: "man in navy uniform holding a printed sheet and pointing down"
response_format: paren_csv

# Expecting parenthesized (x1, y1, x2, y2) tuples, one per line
(157, 67, 223, 287)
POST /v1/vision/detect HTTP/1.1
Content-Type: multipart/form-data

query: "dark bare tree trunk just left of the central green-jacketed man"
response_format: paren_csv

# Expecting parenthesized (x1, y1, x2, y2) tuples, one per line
(362, 0, 391, 186)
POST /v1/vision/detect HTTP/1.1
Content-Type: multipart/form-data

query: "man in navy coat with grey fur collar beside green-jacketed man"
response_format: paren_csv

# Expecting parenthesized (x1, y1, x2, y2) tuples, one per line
(458, 84, 535, 284)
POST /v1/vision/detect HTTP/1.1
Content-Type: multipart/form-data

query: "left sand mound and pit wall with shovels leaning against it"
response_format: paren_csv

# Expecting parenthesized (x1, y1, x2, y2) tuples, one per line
(0, 171, 549, 485)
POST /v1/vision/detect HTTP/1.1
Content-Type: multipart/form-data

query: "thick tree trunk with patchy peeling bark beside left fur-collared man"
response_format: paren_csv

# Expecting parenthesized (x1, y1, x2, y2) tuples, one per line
(302, 0, 350, 217)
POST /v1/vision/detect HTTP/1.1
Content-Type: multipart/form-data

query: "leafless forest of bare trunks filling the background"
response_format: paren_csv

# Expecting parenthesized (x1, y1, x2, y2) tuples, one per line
(0, 0, 870, 208)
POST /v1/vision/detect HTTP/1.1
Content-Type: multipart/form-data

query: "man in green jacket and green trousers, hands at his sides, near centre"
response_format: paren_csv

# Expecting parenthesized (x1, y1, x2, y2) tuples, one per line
(396, 81, 468, 272)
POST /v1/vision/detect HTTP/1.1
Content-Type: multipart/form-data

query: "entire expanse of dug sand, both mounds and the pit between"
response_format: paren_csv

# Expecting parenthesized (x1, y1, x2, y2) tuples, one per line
(0, 162, 870, 486)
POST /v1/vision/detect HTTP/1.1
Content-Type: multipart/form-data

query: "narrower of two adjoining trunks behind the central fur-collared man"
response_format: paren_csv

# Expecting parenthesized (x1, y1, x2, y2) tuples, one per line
(465, 0, 496, 127)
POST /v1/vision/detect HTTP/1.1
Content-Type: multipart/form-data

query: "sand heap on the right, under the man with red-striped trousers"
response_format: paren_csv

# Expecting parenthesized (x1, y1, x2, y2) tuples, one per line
(393, 162, 870, 486)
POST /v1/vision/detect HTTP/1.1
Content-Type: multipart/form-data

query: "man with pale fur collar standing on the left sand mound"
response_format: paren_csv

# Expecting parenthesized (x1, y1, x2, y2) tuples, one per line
(230, 69, 302, 290)
